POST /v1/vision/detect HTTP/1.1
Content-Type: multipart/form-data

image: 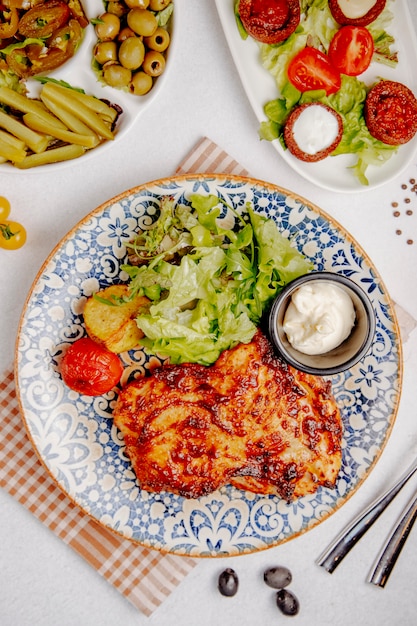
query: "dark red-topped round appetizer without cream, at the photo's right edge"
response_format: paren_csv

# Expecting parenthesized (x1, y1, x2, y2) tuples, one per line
(364, 80, 417, 146)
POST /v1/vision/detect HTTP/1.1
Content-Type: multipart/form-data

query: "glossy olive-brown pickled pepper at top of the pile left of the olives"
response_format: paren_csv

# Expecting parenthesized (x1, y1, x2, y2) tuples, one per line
(18, 0, 71, 39)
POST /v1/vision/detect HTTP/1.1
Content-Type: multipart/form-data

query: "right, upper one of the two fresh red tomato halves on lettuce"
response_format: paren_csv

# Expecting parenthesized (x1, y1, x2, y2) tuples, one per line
(329, 26, 374, 76)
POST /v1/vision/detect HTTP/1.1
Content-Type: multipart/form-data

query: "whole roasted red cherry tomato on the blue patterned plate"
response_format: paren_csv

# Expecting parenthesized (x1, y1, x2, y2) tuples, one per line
(61, 337, 123, 396)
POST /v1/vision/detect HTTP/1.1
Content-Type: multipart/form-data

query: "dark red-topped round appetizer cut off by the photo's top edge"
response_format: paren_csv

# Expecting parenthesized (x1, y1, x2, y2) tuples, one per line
(238, 0, 300, 44)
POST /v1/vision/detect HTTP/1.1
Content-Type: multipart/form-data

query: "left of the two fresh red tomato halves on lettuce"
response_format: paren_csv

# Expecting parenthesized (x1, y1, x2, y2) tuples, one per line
(288, 46, 341, 95)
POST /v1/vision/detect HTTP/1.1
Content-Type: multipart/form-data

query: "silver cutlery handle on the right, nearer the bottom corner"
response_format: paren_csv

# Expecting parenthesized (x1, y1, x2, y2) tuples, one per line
(368, 495, 417, 587)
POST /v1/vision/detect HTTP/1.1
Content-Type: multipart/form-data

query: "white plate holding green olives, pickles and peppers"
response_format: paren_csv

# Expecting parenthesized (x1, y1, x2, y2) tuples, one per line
(0, 0, 176, 174)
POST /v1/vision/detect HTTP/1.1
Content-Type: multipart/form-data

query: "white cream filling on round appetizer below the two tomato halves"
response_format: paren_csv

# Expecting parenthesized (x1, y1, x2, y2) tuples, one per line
(292, 106, 339, 154)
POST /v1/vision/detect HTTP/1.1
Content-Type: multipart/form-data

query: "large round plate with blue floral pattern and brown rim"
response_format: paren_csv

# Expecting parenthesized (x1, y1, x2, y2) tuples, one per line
(16, 175, 402, 556)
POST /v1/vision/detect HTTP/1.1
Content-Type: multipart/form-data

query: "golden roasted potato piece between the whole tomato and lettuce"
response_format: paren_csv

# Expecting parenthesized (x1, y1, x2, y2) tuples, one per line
(84, 285, 149, 353)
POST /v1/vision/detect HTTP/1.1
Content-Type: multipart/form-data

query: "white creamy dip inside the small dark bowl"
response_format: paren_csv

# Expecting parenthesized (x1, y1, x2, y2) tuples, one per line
(283, 282, 355, 355)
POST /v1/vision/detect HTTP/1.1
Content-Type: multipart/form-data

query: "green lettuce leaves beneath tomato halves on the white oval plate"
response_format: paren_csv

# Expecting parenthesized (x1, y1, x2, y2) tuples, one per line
(239, 0, 397, 185)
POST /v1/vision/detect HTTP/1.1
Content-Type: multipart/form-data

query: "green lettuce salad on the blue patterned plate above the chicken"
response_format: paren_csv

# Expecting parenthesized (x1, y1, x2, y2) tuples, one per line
(122, 194, 312, 365)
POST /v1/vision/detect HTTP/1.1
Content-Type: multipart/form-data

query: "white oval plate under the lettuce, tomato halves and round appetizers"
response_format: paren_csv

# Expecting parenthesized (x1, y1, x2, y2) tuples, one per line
(215, 0, 417, 193)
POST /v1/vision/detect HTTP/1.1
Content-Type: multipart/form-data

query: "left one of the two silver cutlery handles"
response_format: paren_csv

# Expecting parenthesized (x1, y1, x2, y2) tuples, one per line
(317, 460, 417, 574)
